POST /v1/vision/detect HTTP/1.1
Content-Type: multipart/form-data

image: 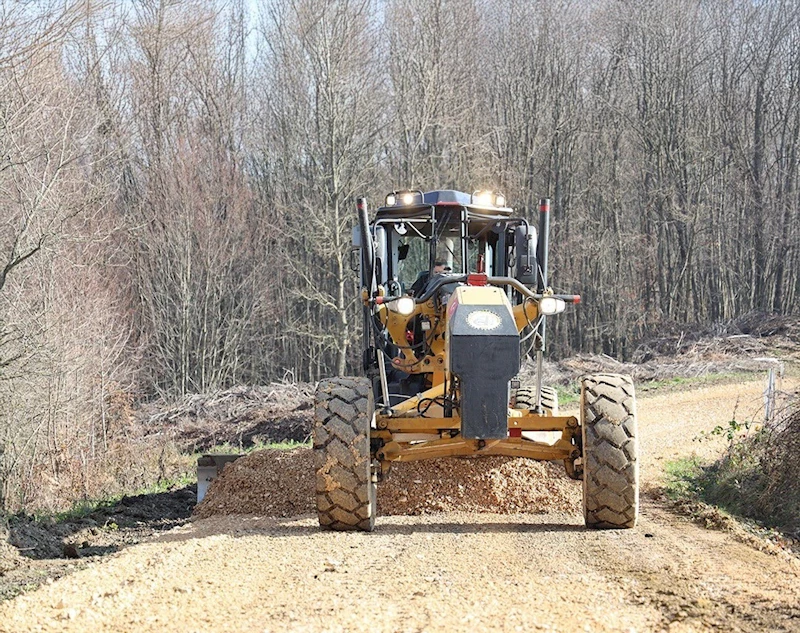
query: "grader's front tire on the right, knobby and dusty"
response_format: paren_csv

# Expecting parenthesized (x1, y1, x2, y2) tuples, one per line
(581, 374, 639, 529)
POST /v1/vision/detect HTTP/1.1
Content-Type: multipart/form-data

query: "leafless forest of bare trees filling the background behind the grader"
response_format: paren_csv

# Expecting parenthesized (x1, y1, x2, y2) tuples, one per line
(0, 0, 800, 511)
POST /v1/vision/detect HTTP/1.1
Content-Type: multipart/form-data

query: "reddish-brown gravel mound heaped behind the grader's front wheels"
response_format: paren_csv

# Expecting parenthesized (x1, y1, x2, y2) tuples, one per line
(194, 448, 581, 518)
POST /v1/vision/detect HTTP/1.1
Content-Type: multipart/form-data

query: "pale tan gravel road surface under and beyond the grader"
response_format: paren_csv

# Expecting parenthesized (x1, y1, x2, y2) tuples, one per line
(0, 383, 800, 633)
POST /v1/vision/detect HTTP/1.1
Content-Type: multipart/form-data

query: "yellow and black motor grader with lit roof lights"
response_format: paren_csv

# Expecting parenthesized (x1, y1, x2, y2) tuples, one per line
(313, 190, 639, 531)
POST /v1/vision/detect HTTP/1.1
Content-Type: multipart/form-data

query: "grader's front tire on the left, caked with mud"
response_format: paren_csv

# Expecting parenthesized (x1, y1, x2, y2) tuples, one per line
(312, 378, 376, 532)
